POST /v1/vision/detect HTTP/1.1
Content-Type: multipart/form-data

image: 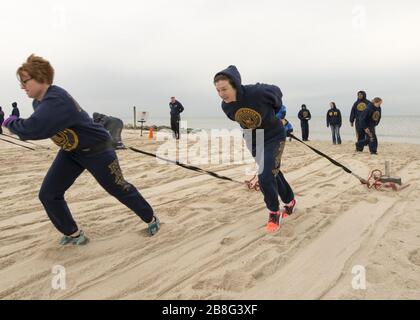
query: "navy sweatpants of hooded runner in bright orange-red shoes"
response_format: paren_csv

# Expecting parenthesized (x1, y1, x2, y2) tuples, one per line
(251, 140, 295, 212)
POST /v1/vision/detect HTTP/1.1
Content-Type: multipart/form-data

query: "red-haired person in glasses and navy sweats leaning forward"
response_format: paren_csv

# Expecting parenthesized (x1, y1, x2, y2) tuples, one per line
(3, 55, 159, 245)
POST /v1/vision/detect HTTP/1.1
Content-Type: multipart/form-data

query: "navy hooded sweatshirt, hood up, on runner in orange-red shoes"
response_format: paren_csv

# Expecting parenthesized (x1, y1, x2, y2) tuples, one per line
(215, 66, 286, 141)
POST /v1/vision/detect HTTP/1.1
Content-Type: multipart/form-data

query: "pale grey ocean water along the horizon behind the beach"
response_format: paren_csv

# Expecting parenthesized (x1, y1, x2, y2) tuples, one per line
(123, 116, 420, 144)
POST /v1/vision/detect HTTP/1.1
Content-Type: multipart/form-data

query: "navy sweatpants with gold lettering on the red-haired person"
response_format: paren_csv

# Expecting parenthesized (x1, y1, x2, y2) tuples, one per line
(39, 150, 153, 236)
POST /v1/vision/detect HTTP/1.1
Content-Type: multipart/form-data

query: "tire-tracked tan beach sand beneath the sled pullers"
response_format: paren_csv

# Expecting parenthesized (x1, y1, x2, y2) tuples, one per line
(0, 130, 420, 299)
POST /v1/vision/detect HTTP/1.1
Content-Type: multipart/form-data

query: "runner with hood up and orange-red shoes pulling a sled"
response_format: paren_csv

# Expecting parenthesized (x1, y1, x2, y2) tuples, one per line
(213, 65, 296, 232)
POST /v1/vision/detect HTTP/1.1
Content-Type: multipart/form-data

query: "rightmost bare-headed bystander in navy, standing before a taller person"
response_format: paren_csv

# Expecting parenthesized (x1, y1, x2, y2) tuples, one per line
(356, 97, 382, 155)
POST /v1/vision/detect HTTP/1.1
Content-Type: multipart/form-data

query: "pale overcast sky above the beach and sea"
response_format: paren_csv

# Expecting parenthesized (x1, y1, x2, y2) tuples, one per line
(0, 0, 420, 118)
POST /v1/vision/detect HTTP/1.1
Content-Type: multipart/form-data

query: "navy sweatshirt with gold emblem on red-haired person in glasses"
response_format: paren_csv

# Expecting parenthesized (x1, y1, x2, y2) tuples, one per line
(8, 86, 111, 151)
